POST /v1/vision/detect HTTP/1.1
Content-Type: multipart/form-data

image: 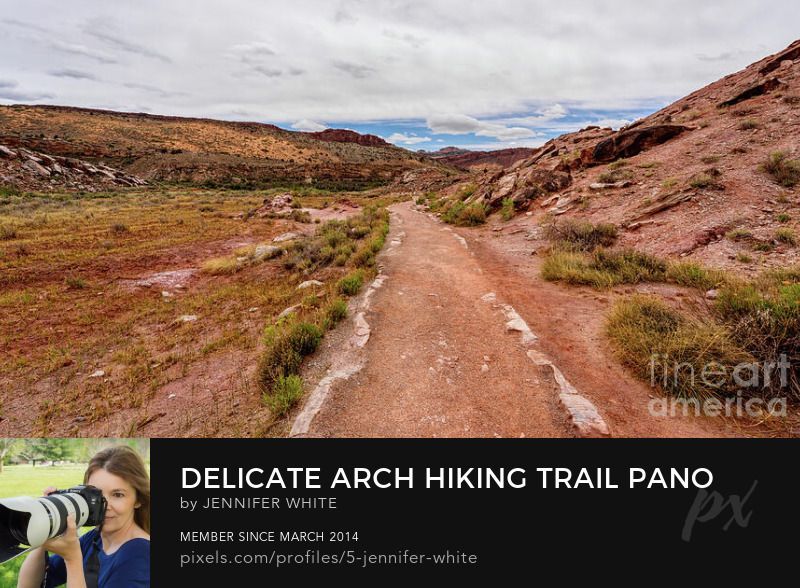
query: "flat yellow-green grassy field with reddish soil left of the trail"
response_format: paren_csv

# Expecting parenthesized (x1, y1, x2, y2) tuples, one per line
(0, 188, 400, 437)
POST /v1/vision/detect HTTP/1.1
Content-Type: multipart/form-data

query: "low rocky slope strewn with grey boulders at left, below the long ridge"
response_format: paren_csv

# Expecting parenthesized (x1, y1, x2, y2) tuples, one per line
(0, 145, 147, 192)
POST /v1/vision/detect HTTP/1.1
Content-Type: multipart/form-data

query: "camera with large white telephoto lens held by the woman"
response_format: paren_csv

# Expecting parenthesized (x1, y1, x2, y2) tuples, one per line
(0, 486, 107, 563)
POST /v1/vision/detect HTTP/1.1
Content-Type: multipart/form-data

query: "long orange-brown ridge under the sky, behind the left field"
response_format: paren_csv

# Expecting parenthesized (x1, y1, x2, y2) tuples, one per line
(0, 105, 441, 188)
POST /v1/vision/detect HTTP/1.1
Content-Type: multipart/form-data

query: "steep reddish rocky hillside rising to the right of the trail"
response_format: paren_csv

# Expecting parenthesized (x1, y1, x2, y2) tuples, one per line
(450, 41, 800, 273)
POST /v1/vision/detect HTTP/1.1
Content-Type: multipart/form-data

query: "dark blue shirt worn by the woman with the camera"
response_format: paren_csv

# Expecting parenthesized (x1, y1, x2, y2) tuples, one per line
(46, 529, 150, 588)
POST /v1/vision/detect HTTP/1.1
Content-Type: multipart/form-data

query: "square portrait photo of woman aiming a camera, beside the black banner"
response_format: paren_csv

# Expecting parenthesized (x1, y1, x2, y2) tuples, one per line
(0, 438, 151, 588)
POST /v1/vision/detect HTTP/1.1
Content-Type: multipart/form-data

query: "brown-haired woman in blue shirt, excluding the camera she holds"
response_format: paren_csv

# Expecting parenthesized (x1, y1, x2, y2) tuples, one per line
(17, 447, 150, 588)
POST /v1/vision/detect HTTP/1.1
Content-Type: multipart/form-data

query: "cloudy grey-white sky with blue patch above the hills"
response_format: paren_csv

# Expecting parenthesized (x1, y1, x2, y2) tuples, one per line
(0, 0, 800, 150)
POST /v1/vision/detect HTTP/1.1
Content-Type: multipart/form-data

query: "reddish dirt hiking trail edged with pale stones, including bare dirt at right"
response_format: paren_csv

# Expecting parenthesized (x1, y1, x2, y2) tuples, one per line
(290, 202, 744, 437)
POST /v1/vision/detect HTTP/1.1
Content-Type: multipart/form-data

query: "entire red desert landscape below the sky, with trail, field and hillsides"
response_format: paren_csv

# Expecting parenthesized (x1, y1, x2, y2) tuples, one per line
(0, 41, 800, 437)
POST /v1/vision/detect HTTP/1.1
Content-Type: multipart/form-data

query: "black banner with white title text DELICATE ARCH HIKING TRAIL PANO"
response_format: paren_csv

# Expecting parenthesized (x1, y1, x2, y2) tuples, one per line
(152, 439, 800, 586)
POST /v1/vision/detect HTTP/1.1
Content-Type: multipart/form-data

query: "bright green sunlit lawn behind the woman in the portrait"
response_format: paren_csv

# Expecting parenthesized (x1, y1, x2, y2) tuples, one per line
(0, 464, 86, 588)
